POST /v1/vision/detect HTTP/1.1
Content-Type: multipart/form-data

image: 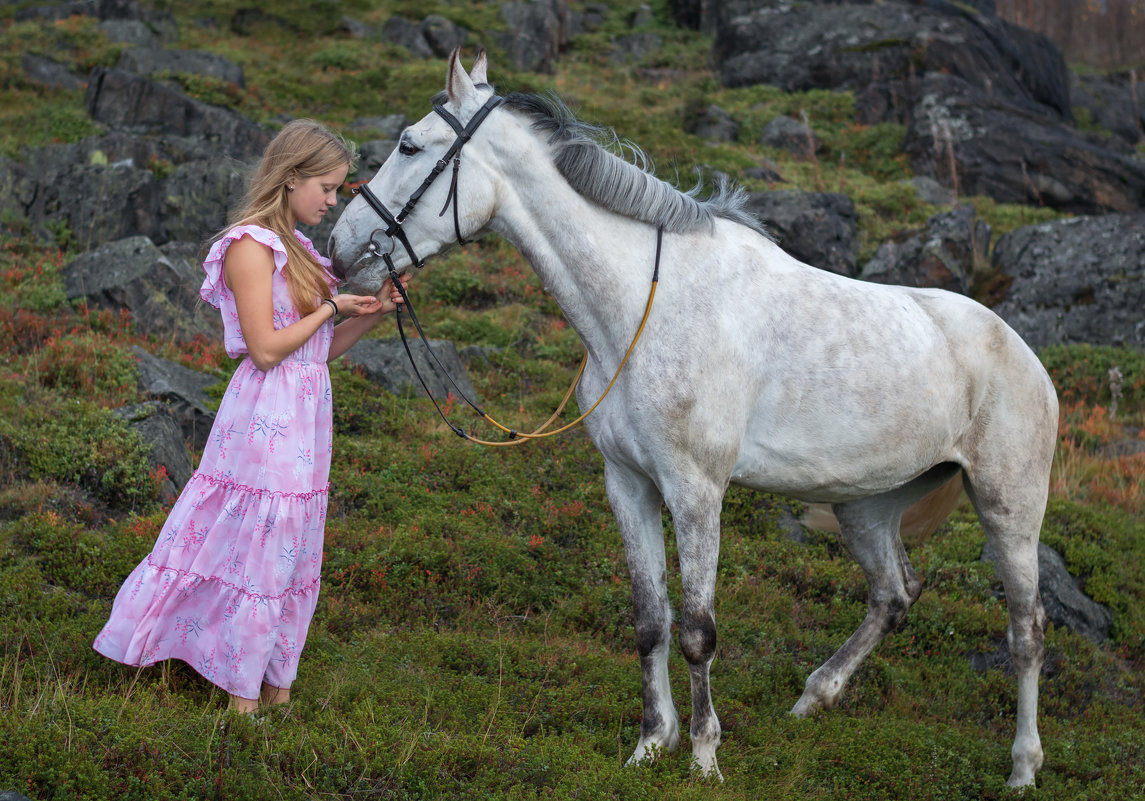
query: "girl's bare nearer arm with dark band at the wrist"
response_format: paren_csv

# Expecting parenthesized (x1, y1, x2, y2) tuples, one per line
(223, 237, 382, 371)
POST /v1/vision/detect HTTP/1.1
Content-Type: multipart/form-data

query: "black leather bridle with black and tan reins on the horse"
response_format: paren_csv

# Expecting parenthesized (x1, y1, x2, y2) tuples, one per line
(354, 95, 664, 446)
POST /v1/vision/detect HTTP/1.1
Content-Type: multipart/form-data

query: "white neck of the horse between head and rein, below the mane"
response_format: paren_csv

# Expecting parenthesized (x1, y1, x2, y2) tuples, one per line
(490, 159, 656, 356)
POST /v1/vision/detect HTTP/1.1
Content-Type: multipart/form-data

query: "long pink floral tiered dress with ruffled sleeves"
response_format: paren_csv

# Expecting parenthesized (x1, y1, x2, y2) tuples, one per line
(94, 225, 333, 698)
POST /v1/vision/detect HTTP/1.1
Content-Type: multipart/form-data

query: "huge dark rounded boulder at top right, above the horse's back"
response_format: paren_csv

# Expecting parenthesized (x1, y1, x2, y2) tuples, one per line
(712, 2, 1069, 122)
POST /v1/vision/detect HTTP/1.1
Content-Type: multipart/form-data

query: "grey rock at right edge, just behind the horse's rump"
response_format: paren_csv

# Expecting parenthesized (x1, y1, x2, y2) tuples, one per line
(993, 213, 1145, 350)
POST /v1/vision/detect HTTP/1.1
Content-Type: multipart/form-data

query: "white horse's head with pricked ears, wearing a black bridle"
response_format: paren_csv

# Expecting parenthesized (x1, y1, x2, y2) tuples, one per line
(327, 50, 499, 292)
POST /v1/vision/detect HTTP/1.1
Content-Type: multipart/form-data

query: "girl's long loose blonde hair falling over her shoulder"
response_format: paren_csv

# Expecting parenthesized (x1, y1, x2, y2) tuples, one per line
(212, 119, 357, 316)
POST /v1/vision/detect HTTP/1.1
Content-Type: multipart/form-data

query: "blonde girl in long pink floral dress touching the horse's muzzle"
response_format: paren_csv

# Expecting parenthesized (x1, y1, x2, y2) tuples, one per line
(95, 120, 401, 712)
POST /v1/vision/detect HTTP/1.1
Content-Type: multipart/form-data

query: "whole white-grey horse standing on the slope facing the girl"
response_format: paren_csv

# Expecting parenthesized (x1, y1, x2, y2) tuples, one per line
(330, 53, 1058, 785)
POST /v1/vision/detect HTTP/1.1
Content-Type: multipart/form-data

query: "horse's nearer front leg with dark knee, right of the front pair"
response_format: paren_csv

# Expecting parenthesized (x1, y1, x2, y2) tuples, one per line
(669, 484, 724, 782)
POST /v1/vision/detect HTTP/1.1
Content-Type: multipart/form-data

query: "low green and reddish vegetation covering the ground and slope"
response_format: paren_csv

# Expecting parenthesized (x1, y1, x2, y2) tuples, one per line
(0, 0, 1145, 801)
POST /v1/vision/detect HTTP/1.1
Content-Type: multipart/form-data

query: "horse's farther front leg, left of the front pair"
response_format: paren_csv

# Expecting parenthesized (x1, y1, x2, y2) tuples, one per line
(605, 460, 680, 764)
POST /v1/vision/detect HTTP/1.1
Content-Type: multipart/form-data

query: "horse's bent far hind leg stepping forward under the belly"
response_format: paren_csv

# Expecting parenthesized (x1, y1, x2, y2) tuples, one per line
(791, 465, 958, 717)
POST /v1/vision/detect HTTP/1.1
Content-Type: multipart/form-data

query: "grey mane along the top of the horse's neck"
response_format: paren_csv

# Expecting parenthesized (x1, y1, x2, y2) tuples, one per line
(505, 93, 768, 237)
